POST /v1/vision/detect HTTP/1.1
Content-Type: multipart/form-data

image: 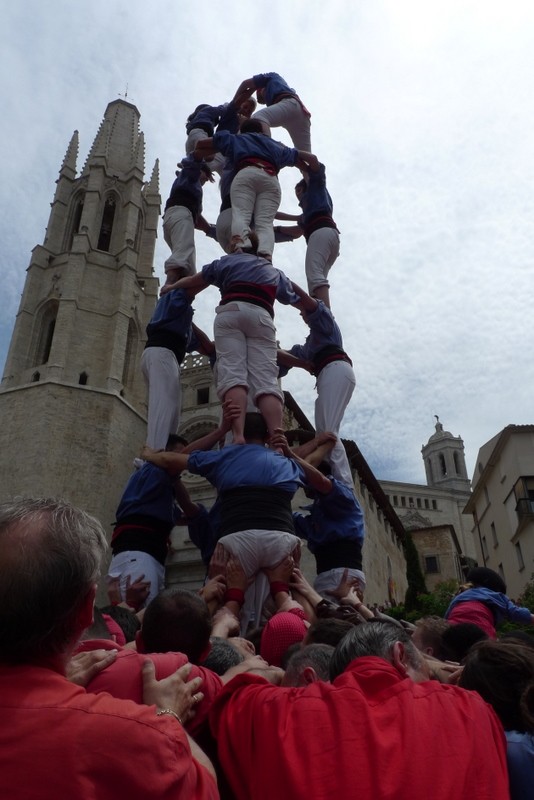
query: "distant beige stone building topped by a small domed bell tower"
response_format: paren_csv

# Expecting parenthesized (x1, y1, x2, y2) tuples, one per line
(380, 418, 476, 591)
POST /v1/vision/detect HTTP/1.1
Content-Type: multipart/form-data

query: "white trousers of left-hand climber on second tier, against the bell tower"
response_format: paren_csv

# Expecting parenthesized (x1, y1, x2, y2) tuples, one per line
(141, 347, 182, 450)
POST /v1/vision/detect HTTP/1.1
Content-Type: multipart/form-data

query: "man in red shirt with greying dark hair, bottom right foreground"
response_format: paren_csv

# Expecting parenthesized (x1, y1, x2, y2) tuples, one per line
(210, 621, 509, 800)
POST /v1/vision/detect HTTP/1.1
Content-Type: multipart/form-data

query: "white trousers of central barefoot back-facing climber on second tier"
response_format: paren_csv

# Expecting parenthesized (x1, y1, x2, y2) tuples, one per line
(213, 302, 284, 403)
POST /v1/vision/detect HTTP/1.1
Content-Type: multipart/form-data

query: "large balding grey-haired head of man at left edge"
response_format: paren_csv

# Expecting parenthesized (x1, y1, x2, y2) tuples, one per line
(0, 498, 107, 663)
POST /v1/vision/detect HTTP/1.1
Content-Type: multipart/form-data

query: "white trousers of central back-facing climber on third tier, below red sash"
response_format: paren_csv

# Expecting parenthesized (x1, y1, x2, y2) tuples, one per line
(230, 167, 282, 256)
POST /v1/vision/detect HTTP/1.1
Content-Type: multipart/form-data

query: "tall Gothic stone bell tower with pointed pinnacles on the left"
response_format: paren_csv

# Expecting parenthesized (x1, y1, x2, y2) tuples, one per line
(0, 100, 161, 532)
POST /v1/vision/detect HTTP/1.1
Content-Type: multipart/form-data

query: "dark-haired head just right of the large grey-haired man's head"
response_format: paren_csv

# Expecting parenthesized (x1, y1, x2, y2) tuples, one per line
(142, 587, 211, 663)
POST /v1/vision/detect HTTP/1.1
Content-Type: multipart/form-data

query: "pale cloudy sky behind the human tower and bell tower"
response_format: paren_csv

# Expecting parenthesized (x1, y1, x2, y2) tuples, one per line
(0, 0, 534, 483)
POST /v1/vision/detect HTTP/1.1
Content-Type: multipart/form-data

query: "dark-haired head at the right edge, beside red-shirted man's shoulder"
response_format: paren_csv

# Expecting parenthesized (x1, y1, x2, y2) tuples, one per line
(459, 640, 534, 733)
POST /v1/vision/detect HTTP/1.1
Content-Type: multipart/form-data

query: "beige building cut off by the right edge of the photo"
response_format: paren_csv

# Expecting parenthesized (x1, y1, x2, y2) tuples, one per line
(465, 425, 534, 598)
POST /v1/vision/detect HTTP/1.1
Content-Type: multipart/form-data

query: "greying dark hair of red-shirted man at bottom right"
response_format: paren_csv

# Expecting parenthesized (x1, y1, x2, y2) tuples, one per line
(330, 620, 428, 681)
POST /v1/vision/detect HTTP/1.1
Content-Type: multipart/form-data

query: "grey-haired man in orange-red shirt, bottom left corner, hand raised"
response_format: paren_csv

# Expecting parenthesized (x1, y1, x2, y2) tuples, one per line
(0, 499, 219, 800)
